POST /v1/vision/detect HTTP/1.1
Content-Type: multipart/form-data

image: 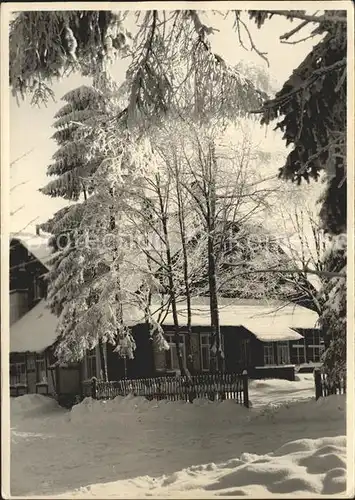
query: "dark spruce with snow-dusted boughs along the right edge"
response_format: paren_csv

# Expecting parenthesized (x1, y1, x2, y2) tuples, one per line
(250, 10, 347, 379)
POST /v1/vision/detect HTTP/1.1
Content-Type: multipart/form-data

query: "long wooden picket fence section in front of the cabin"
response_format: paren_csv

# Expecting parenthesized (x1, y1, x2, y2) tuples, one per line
(83, 373, 249, 407)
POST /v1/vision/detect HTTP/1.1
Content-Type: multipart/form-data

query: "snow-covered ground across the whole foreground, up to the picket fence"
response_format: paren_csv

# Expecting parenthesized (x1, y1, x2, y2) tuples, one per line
(11, 374, 346, 498)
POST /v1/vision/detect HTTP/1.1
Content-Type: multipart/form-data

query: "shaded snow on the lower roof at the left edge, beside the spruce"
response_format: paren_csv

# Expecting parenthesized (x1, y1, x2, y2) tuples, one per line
(10, 300, 58, 352)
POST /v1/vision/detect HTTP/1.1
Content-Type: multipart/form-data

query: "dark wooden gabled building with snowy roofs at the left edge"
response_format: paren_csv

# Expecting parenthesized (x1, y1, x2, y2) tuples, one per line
(9, 231, 81, 402)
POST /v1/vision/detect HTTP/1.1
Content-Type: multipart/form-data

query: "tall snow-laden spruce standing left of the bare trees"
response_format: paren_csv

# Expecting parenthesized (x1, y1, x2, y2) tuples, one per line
(41, 72, 152, 361)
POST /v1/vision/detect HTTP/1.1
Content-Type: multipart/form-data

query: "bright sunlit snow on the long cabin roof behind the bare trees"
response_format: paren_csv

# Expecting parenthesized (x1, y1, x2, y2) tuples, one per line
(152, 297, 318, 342)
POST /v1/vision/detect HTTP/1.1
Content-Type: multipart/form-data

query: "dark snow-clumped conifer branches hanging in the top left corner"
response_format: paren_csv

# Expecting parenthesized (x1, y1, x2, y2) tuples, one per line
(9, 11, 129, 102)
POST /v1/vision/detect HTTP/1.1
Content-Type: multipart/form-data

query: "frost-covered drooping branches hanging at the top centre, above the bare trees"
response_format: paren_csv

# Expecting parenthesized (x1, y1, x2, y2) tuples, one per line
(127, 11, 266, 129)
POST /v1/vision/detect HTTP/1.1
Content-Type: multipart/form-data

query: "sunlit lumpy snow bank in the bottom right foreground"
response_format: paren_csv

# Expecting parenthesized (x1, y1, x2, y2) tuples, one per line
(57, 436, 346, 498)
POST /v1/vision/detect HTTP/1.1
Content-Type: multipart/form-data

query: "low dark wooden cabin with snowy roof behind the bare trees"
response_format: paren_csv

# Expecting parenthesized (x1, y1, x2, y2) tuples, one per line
(98, 297, 323, 380)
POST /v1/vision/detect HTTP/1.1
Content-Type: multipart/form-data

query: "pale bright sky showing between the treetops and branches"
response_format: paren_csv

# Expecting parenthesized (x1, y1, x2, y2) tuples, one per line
(10, 8, 317, 232)
